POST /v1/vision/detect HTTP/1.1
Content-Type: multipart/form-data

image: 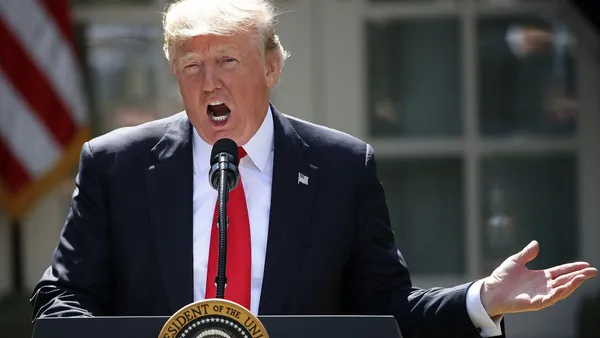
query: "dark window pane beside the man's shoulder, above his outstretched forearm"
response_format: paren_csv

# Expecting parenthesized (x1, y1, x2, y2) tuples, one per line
(378, 159, 464, 274)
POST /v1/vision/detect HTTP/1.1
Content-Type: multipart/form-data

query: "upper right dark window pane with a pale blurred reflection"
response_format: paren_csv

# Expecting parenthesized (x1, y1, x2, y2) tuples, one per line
(479, 18, 578, 135)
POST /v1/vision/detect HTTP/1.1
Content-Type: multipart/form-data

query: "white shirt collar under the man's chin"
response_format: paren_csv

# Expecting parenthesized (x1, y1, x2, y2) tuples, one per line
(192, 106, 274, 171)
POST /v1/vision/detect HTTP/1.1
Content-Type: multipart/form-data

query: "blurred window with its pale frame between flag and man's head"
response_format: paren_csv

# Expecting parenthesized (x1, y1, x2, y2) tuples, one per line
(74, 0, 181, 135)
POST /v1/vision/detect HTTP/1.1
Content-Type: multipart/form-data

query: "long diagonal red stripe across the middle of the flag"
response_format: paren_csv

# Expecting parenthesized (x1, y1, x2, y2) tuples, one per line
(0, 20, 76, 146)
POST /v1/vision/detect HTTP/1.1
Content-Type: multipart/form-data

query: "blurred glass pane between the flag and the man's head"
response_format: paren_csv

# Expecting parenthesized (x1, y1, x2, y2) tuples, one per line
(84, 24, 168, 133)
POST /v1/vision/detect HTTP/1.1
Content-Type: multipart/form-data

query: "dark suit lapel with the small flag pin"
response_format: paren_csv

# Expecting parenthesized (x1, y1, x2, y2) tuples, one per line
(259, 107, 318, 314)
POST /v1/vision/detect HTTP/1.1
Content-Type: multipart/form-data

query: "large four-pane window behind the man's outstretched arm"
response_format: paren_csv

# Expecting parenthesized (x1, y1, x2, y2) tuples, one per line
(324, 0, 580, 278)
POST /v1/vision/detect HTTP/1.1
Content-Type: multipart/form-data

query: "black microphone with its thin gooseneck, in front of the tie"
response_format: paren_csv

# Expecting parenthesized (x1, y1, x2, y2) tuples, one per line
(207, 138, 239, 299)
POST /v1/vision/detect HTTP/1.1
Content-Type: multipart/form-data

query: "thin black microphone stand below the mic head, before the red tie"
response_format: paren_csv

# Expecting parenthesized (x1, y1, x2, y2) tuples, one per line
(215, 170, 229, 299)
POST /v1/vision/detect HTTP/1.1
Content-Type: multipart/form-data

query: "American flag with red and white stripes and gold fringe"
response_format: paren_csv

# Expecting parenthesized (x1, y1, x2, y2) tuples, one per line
(0, 0, 88, 219)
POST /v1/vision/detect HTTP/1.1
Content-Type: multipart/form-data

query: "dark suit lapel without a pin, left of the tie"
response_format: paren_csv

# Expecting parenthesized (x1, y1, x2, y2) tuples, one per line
(146, 113, 194, 313)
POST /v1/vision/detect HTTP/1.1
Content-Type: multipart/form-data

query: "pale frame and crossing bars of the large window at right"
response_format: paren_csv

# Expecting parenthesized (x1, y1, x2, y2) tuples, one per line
(315, 0, 590, 286)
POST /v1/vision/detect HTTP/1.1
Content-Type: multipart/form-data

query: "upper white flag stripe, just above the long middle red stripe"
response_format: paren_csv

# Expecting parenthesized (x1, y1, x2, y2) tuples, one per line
(0, 0, 87, 125)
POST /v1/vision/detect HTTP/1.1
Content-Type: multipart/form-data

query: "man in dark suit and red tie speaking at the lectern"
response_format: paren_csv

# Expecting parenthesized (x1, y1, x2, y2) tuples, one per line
(32, 0, 596, 337)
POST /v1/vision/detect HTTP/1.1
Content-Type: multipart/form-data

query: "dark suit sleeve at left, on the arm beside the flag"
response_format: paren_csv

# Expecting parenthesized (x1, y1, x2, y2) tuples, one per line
(31, 143, 110, 322)
